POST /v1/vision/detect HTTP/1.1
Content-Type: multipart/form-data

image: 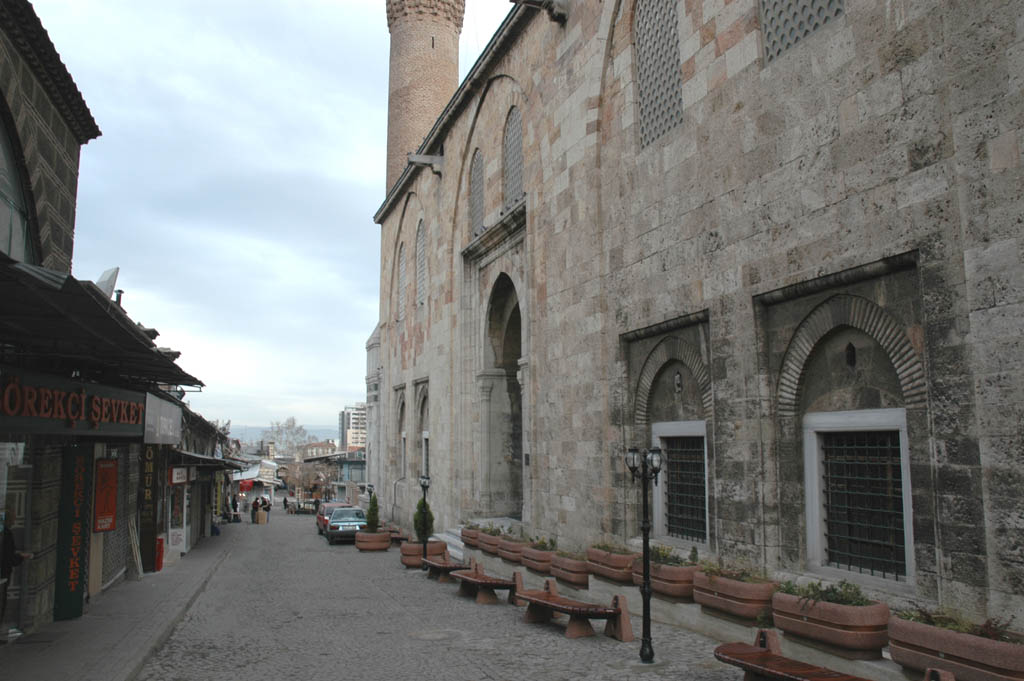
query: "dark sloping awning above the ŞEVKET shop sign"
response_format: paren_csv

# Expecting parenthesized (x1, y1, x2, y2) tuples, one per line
(0, 253, 203, 387)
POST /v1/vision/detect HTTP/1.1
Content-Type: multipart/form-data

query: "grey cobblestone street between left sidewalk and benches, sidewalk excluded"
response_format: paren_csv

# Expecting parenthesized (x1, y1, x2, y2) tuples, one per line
(138, 512, 741, 681)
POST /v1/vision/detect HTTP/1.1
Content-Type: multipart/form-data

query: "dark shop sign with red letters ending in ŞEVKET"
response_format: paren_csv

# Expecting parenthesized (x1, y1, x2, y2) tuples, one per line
(0, 366, 145, 437)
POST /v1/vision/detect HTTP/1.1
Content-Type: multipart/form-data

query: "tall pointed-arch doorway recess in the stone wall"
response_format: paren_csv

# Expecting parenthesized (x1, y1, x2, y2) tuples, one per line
(479, 273, 523, 519)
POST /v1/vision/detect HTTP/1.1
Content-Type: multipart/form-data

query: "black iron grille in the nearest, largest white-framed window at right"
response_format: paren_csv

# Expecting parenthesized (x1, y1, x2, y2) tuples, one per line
(821, 430, 906, 580)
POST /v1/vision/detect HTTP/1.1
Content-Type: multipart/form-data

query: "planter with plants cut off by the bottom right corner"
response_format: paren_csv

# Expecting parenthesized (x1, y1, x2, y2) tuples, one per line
(889, 607, 1024, 681)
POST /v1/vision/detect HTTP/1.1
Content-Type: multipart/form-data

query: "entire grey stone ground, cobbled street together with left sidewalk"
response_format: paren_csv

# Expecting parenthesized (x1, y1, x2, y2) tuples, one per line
(0, 513, 741, 681)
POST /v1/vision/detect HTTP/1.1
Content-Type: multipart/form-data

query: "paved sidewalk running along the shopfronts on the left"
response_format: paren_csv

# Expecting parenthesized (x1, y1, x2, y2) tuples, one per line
(0, 524, 242, 681)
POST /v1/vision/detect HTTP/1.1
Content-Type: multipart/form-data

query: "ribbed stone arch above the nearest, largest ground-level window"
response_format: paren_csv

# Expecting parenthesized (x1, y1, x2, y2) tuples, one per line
(777, 294, 927, 417)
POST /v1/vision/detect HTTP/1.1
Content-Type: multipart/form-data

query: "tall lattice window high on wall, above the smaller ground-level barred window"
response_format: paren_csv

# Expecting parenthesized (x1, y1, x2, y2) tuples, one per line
(633, 0, 683, 146)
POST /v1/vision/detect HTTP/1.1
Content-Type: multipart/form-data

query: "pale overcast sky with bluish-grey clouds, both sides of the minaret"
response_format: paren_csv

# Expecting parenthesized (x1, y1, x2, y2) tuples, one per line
(32, 0, 513, 426)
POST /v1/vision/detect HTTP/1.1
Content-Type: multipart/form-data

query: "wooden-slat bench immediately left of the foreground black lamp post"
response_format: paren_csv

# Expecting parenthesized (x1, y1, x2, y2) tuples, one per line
(514, 572, 633, 642)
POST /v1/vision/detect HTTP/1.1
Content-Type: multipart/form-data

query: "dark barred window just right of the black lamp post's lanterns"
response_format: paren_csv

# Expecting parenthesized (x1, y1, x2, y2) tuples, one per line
(662, 437, 708, 542)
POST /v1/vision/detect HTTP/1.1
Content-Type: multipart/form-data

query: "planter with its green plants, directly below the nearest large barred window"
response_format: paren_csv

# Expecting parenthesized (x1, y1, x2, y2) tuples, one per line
(771, 580, 889, 659)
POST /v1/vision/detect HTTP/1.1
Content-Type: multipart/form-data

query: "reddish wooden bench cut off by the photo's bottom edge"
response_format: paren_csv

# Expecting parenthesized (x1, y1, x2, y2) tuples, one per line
(715, 629, 954, 681)
